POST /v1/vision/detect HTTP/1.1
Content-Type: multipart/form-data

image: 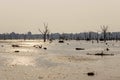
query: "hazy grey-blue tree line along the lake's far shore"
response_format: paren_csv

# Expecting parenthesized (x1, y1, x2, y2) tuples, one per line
(0, 31, 120, 41)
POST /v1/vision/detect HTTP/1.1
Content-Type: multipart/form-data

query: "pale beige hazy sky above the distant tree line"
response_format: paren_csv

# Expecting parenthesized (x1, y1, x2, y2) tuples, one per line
(0, 0, 120, 33)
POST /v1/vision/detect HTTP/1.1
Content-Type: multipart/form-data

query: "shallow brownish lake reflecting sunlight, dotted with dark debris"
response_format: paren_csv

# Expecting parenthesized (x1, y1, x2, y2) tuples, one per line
(0, 40, 120, 80)
